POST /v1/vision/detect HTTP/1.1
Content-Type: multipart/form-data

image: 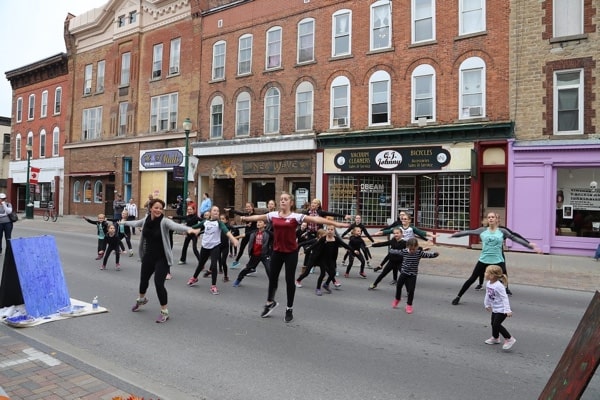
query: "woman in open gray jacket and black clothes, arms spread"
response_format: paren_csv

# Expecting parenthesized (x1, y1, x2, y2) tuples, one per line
(123, 199, 200, 323)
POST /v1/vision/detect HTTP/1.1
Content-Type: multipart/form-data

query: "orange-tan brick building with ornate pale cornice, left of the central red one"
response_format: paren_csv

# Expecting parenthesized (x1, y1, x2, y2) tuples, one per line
(65, 0, 200, 215)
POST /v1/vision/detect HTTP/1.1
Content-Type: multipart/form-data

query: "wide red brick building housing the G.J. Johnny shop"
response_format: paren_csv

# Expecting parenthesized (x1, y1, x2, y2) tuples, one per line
(193, 0, 513, 239)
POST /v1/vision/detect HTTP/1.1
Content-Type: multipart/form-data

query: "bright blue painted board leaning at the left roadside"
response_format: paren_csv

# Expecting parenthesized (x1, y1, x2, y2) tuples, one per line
(11, 236, 71, 318)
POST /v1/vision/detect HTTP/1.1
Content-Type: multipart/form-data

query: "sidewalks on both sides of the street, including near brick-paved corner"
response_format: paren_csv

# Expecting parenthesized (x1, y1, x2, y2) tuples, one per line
(0, 216, 600, 400)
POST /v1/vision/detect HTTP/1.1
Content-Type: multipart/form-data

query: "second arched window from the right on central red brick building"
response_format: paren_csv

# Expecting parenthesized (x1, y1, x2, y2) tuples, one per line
(412, 64, 435, 122)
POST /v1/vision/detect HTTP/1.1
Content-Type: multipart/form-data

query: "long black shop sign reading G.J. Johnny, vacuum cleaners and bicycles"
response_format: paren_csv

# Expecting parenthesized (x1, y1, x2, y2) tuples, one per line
(334, 146, 450, 171)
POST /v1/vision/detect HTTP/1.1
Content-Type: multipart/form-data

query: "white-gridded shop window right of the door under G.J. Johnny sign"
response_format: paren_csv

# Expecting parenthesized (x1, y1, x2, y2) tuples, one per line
(420, 174, 471, 230)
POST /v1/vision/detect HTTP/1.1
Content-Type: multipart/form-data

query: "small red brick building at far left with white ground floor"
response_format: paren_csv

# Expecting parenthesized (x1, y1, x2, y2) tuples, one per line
(5, 53, 71, 214)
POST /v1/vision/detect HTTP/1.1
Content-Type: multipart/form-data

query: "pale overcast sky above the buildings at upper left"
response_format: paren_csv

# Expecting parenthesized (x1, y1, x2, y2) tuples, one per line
(0, 0, 109, 117)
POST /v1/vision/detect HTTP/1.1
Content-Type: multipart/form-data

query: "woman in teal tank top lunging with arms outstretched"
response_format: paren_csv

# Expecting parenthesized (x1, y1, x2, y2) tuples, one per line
(450, 212, 542, 306)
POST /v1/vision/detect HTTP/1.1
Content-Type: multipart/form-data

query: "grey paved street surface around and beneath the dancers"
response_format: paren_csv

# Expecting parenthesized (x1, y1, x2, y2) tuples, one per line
(0, 217, 600, 400)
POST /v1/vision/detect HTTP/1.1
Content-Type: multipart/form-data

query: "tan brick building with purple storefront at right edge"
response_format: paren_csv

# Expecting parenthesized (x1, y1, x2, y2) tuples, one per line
(507, 0, 600, 256)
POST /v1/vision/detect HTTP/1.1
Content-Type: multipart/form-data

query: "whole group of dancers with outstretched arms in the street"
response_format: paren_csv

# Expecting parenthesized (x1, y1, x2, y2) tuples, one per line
(86, 193, 541, 349)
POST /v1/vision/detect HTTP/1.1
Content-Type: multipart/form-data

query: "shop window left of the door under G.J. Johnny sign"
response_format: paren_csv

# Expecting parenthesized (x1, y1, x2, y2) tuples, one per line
(327, 175, 392, 226)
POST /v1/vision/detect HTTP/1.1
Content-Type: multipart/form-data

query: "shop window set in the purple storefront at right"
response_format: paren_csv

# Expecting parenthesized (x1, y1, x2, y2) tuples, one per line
(555, 168, 600, 238)
